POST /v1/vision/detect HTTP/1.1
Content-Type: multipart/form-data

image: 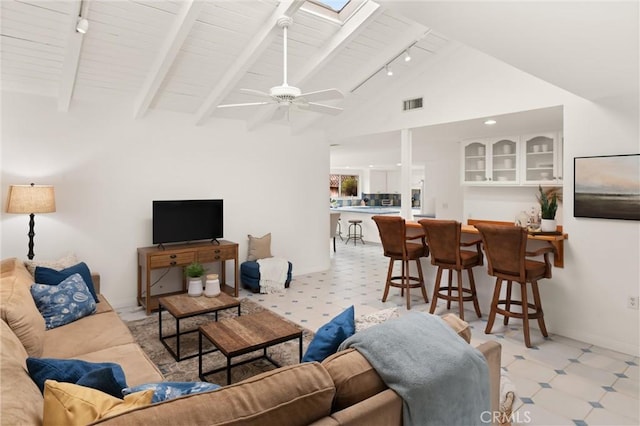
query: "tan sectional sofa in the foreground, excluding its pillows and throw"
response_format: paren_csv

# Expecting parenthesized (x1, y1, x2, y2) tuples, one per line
(0, 259, 501, 426)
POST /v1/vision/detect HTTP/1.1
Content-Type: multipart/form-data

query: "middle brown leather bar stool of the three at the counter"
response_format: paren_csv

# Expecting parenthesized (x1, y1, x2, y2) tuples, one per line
(418, 219, 483, 320)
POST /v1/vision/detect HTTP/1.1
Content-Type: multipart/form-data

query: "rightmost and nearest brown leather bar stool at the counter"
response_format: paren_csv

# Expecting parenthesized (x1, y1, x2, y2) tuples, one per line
(475, 223, 553, 348)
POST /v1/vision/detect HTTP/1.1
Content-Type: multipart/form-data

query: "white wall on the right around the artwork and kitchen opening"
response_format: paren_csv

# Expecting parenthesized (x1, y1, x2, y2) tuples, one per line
(332, 47, 640, 355)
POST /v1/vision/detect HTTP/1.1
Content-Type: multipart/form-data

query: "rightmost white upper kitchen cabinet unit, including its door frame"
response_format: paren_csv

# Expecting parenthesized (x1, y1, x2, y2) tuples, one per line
(522, 133, 562, 185)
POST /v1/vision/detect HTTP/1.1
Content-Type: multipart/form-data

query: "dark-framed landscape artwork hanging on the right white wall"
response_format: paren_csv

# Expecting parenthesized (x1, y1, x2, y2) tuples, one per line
(573, 154, 640, 220)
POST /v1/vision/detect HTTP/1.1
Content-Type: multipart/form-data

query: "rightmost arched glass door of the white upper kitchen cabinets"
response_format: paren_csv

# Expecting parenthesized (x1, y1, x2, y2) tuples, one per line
(523, 134, 559, 185)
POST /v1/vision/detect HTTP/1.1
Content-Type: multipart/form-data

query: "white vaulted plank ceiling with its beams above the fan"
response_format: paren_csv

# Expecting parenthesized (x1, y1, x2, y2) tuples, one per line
(0, 0, 448, 126)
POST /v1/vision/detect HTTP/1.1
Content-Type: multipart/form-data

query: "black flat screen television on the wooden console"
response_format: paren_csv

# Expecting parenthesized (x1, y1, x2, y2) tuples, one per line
(152, 200, 224, 244)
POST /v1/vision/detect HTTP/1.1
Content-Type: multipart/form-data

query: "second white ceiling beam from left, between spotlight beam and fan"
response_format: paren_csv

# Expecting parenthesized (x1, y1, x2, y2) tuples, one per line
(133, 0, 205, 118)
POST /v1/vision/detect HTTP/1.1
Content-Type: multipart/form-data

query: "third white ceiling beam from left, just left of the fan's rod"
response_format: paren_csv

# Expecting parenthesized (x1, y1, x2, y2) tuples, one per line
(196, 0, 304, 125)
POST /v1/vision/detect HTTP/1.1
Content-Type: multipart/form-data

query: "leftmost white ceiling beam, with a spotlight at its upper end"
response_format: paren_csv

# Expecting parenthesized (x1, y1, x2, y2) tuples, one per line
(58, 0, 89, 112)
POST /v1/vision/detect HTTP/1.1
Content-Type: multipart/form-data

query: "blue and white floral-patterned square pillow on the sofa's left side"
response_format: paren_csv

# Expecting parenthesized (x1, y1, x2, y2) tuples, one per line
(31, 274, 96, 330)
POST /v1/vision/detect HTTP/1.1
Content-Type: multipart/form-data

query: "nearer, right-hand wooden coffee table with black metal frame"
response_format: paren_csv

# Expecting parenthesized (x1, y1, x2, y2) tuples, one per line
(198, 311, 302, 385)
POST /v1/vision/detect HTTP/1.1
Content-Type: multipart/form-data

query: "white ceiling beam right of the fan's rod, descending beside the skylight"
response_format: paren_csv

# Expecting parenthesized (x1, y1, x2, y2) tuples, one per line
(247, 2, 382, 130)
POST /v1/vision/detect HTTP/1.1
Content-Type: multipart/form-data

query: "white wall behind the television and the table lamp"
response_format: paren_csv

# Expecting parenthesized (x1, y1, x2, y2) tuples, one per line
(1, 93, 329, 306)
